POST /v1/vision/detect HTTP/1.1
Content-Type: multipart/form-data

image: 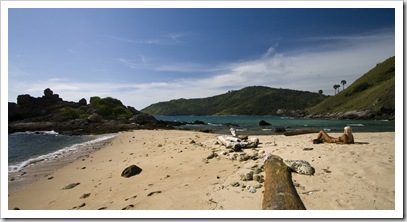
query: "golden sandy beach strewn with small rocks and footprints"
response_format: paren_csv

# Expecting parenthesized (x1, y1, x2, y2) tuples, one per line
(8, 130, 395, 214)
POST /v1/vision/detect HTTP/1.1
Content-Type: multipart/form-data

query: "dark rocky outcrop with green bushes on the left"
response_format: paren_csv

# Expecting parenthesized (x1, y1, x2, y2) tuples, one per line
(8, 89, 171, 134)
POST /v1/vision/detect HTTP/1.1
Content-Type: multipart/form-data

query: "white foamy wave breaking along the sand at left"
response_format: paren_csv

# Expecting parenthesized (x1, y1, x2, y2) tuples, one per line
(8, 131, 117, 172)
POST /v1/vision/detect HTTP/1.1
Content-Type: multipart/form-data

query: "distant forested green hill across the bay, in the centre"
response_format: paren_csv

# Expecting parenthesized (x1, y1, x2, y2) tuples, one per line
(141, 86, 326, 116)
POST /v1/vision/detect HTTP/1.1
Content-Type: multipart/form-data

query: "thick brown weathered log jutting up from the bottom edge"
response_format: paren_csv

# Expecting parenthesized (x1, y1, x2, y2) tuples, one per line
(262, 155, 305, 210)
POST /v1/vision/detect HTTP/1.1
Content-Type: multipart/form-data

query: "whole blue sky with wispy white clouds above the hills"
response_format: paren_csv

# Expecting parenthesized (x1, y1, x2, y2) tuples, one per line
(4, 4, 395, 110)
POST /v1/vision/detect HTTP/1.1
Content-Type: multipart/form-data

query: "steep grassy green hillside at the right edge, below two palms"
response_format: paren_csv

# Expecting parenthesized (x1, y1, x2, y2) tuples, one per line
(306, 56, 395, 119)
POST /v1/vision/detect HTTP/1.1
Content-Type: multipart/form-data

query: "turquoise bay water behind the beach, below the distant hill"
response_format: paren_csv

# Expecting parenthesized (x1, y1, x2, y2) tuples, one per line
(155, 116, 395, 135)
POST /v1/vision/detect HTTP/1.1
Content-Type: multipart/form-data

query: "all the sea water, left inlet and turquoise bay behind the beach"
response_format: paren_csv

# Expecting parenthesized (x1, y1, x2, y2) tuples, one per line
(8, 116, 395, 173)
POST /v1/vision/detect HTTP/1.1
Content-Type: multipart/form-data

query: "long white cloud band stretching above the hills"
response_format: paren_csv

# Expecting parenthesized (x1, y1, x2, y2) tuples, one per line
(9, 29, 395, 109)
